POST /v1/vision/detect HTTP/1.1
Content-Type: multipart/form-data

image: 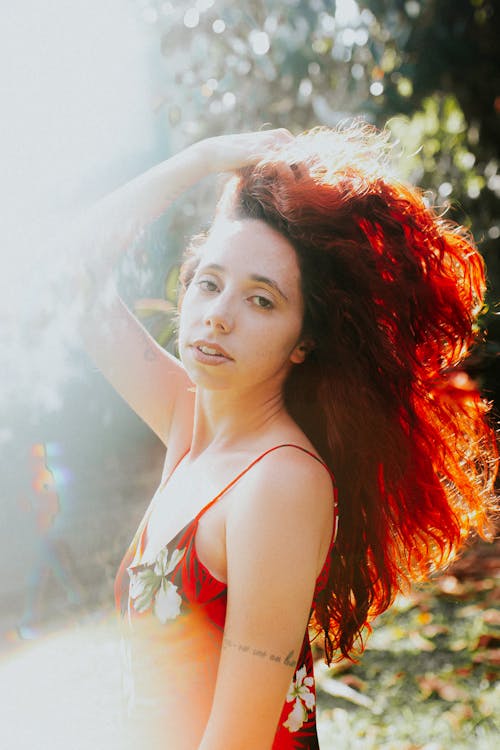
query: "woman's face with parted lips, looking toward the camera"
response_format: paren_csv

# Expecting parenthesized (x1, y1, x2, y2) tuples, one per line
(179, 217, 305, 390)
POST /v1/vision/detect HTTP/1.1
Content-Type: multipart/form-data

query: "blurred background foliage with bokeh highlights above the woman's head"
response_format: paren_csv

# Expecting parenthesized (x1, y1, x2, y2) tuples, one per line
(135, 0, 500, 394)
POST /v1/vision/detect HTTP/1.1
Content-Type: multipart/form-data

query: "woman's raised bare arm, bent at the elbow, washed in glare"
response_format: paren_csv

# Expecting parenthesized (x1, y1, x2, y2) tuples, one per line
(77, 130, 291, 444)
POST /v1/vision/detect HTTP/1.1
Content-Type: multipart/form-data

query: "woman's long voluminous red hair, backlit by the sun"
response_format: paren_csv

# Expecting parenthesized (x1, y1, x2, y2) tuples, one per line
(182, 122, 497, 663)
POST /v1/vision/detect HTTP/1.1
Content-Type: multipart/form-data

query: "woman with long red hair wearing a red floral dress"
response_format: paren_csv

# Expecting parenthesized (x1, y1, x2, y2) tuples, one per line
(80, 124, 495, 750)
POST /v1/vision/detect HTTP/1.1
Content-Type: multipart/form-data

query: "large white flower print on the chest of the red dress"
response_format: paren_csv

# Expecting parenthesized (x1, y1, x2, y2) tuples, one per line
(128, 547, 186, 625)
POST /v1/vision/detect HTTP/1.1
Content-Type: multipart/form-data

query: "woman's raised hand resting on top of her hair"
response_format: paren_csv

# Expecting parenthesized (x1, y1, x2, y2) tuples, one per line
(196, 128, 294, 172)
